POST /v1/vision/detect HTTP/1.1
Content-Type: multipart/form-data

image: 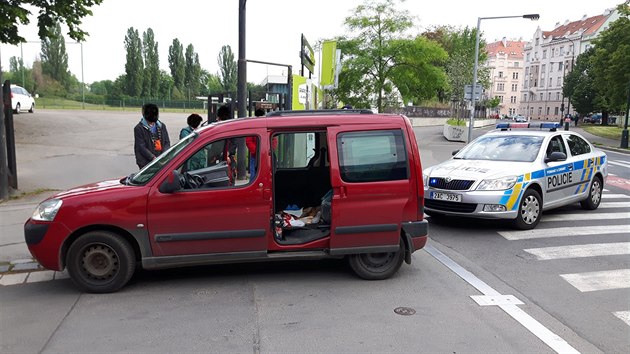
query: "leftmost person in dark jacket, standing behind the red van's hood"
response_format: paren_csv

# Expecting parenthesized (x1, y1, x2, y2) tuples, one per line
(133, 103, 171, 169)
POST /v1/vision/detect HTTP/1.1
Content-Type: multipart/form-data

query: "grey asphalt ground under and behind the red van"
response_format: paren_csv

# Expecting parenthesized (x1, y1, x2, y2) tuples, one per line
(0, 110, 630, 353)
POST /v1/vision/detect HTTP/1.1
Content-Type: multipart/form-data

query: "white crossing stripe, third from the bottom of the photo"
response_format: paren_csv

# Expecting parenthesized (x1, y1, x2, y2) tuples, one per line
(523, 242, 630, 260)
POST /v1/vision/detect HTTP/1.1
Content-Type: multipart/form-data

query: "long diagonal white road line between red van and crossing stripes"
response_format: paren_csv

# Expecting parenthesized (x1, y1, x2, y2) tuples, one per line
(424, 245, 579, 353)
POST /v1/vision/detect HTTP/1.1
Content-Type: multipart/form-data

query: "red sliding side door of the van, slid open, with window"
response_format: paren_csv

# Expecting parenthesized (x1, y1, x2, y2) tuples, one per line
(328, 124, 414, 254)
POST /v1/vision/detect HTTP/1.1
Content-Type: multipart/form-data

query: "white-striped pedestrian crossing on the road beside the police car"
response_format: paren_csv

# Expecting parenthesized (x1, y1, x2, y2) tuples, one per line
(498, 189, 630, 326)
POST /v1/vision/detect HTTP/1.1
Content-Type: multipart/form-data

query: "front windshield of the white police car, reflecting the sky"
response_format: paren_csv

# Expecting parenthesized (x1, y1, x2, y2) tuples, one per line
(455, 135, 544, 162)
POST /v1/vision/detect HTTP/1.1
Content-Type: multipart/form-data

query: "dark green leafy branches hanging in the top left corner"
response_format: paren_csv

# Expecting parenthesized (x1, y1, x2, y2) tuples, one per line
(0, 0, 103, 45)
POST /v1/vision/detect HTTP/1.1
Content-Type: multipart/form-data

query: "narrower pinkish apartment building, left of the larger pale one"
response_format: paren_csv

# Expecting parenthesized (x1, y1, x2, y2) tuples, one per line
(486, 37, 526, 116)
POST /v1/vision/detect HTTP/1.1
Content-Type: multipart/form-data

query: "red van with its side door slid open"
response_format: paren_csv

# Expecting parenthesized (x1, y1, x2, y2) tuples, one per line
(24, 110, 428, 293)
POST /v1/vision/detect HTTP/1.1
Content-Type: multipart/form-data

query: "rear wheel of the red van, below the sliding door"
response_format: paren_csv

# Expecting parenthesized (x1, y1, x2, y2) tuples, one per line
(348, 239, 405, 280)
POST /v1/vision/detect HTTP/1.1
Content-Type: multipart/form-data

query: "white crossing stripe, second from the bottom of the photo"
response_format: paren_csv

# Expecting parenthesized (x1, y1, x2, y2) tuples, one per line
(560, 269, 630, 292)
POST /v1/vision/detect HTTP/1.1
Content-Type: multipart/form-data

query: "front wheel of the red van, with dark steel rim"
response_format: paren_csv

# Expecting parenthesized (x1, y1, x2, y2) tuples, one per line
(66, 231, 136, 293)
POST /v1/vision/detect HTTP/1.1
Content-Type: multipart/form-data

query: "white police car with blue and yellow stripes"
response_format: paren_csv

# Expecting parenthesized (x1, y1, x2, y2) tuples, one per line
(423, 123, 608, 230)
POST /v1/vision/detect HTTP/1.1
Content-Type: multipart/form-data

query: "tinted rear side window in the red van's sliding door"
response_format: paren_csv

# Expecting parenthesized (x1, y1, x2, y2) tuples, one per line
(337, 130, 409, 182)
